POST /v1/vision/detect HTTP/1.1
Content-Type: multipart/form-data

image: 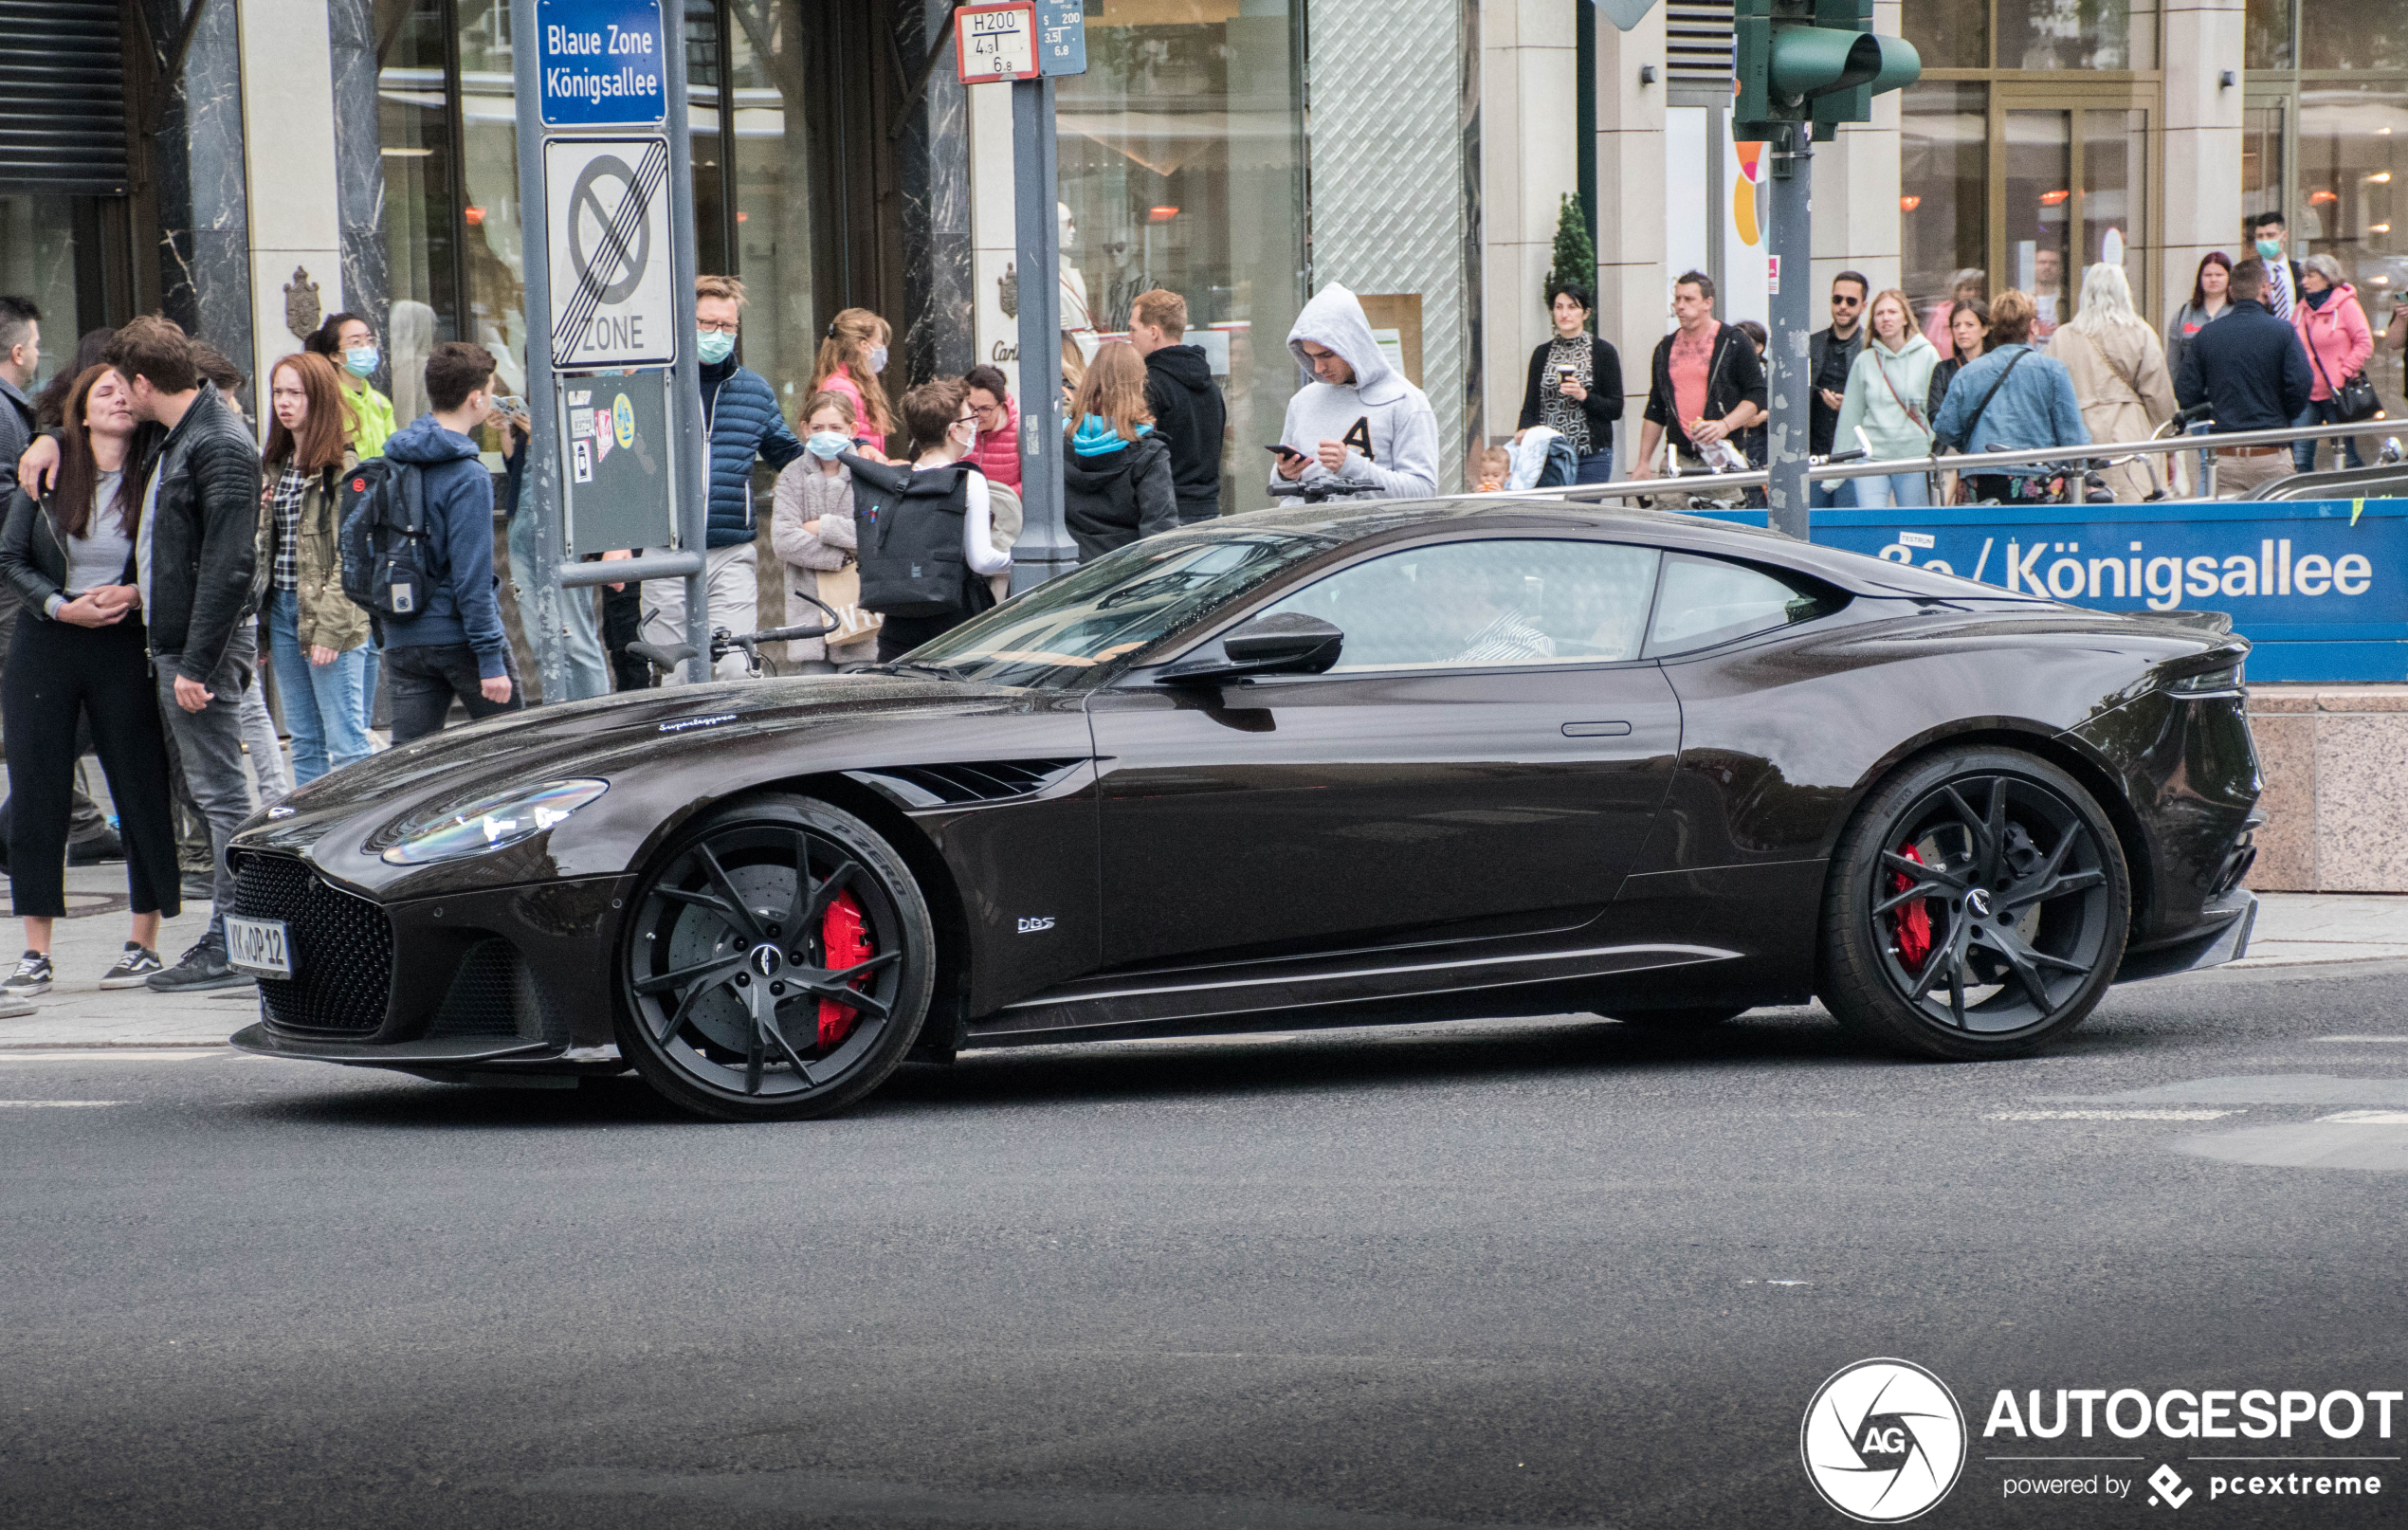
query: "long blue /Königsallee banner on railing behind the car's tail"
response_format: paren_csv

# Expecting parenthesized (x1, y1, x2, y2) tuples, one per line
(1709, 499, 2408, 682)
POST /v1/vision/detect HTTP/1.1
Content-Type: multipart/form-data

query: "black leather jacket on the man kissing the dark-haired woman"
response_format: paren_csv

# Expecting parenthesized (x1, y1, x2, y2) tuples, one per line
(142, 383, 260, 684)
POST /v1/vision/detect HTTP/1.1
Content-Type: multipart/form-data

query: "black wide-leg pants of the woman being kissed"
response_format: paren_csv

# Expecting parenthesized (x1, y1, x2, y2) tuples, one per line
(0, 612, 183, 918)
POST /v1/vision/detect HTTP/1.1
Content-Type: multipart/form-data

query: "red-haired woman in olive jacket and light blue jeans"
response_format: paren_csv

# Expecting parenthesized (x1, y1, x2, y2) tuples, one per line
(263, 352, 375, 786)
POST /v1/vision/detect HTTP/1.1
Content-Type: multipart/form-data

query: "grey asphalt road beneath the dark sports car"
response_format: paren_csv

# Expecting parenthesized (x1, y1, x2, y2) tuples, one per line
(0, 964, 2408, 1530)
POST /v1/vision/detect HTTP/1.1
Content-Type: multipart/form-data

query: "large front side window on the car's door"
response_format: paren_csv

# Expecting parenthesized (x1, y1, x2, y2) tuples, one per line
(1271, 539, 1657, 675)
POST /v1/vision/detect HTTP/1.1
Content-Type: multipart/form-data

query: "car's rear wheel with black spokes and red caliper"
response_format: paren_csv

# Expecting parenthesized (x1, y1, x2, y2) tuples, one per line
(1820, 747, 2131, 1060)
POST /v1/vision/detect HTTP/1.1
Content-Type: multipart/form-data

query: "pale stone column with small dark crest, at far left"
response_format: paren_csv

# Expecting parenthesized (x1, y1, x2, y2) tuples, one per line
(238, 0, 342, 397)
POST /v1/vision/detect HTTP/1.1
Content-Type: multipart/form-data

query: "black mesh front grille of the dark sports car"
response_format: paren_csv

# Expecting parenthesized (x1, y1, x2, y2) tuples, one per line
(233, 853, 392, 1036)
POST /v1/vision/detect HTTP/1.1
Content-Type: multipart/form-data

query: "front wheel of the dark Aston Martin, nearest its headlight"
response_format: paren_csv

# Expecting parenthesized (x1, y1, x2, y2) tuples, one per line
(619, 797, 937, 1120)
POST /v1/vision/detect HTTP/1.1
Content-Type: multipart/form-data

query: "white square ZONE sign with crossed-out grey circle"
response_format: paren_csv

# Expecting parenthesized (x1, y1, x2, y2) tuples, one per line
(544, 137, 677, 371)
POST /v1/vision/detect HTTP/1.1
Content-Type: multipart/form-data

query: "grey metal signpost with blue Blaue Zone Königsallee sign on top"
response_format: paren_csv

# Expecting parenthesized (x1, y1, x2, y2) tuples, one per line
(510, 0, 710, 701)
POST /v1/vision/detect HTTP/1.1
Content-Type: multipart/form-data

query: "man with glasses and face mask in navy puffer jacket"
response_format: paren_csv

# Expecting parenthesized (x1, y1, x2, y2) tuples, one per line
(643, 277, 802, 684)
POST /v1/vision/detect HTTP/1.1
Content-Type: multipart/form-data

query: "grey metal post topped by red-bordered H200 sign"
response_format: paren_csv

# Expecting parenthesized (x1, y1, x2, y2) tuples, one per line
(954, 0, 1086, 591)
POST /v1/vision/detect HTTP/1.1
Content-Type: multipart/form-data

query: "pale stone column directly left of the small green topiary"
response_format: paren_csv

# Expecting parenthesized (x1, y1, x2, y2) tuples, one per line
(1481, 0, 1579, 452)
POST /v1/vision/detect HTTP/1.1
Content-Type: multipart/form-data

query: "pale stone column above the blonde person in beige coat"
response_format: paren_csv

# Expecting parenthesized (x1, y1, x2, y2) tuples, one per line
(2157, 0, 2244, 328)
